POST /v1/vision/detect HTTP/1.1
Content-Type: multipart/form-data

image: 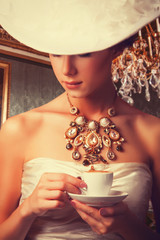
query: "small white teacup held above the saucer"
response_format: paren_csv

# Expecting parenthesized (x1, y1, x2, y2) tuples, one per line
(82, 171, 113, 196)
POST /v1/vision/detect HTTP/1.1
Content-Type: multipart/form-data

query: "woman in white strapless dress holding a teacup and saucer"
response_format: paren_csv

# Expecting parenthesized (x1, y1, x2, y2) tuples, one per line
(0, 1, 160, 240)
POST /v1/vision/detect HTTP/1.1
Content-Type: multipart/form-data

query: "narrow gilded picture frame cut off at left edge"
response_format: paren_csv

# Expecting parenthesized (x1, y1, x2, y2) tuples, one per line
(0, 61, 11, 126)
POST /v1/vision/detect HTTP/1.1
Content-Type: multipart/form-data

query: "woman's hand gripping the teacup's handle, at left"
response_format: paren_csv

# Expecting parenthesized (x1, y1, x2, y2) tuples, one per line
(25, 173, 86, 216)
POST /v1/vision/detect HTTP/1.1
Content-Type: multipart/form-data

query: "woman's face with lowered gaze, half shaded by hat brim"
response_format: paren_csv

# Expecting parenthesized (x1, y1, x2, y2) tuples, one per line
(50, 49, 113, 97)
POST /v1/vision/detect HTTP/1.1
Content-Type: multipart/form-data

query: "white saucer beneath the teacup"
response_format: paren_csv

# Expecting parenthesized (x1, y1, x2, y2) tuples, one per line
(68, 190, 128, 207)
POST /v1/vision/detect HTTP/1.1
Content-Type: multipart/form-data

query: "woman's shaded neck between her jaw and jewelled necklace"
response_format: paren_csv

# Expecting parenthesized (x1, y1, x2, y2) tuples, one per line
(68, 86, 116, 120)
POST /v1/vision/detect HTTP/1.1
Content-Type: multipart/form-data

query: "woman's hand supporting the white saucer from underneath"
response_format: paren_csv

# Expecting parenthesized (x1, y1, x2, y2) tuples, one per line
(71, 200, 129, 235)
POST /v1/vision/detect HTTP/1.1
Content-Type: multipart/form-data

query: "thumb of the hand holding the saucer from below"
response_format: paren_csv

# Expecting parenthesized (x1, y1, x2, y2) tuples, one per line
(99, 202, 128, 217)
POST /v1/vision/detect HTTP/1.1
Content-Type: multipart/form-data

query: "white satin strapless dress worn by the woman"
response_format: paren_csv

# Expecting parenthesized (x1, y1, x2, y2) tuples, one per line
(20, 158, 152, 240)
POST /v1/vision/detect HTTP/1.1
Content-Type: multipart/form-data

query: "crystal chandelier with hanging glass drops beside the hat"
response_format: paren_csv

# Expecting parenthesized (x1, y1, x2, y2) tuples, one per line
(112, 18, 160, 105)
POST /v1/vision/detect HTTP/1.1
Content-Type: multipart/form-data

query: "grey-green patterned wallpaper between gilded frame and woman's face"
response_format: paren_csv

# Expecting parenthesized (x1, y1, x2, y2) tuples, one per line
(0, 54, 63, 116)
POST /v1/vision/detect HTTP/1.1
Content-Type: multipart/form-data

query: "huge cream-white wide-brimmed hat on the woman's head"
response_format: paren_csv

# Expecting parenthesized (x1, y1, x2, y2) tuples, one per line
(0, 0, 160, 54)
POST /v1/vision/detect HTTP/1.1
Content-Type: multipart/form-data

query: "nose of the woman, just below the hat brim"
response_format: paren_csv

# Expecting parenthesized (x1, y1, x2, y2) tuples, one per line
(62, 55, 77, 76)
